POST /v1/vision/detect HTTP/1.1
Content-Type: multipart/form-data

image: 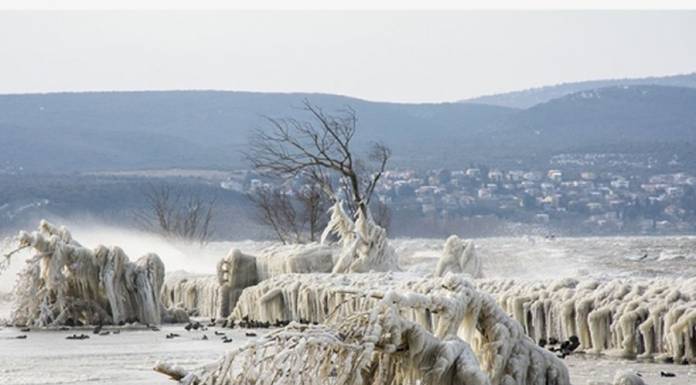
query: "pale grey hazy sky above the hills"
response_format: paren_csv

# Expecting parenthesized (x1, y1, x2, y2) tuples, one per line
(0, 11, 696, 102)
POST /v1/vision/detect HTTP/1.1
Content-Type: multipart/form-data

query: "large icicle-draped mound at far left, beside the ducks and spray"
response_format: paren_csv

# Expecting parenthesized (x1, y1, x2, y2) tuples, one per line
(11, 221, 180, 326)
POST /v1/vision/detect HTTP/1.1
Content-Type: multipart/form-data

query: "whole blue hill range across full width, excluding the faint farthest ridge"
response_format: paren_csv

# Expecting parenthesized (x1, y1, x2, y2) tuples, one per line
(0, 85, 696, 173)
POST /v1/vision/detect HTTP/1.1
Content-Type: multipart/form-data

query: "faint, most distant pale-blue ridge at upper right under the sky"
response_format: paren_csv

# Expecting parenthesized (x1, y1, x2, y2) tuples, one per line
(462, 73, 696, 108)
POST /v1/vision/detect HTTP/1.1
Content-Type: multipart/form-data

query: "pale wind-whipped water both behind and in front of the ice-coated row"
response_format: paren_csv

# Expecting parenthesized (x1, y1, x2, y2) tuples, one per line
(0, 229, 696, 385)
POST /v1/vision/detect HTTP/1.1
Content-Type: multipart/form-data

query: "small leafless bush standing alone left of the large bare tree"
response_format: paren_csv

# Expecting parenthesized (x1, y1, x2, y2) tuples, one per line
(135, 184, 215, 244)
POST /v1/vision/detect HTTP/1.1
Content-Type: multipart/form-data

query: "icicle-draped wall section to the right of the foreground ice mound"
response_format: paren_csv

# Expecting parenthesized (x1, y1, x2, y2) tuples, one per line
(477, 278, 696, 363)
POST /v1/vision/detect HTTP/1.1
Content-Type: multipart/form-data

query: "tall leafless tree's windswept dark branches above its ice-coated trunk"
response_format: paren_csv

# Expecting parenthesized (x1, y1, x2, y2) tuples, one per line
(247, 100, 391, 222)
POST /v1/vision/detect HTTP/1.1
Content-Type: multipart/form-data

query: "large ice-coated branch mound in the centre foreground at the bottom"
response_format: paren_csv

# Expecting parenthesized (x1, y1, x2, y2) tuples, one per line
(155, 297, 491, 385)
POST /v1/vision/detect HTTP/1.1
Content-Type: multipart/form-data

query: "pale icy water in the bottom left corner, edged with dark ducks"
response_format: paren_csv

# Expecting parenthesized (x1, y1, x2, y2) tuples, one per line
(0, 325, 267, 385)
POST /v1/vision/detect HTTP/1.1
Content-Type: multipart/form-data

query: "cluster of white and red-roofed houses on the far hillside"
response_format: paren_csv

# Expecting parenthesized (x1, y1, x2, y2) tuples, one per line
(239, 159, 696, 236)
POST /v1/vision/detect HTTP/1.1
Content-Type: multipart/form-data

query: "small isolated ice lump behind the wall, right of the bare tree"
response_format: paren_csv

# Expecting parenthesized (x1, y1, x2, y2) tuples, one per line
(435, 235, 483, 278)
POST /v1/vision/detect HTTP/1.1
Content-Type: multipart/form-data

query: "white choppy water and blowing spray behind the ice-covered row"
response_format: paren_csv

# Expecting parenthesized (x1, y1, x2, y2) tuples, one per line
(0, 220, 696, 293)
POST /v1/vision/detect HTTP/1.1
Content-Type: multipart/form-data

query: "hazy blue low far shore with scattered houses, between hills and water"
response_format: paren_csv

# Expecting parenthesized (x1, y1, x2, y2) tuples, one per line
(0, 153, 696, 239)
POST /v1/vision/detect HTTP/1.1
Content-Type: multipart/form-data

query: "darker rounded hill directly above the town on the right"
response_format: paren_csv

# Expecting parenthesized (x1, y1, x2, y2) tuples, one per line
(506, 86, 696, 149)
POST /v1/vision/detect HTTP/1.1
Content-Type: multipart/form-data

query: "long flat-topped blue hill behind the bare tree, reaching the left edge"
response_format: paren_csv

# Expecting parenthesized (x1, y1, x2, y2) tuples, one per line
(0, 91, 514, 172)
